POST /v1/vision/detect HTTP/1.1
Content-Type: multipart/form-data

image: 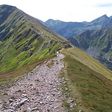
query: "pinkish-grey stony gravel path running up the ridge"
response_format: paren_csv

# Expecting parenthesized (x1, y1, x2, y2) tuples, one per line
(0, 54, 65, 112)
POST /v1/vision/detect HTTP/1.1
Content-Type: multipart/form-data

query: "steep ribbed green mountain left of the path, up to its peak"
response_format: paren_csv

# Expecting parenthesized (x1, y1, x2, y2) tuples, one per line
(0, 5, 68, 83)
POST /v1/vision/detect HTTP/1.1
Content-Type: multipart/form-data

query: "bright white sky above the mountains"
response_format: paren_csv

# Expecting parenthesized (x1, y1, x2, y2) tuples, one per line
(0, 0, 112, 22)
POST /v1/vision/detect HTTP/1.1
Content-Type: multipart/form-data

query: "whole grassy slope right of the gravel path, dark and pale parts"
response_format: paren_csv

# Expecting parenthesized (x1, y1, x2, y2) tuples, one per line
(63, 48, 112, 112)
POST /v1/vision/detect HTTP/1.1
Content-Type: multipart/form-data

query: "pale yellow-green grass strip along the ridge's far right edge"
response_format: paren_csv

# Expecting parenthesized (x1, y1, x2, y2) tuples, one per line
(63, 48, 112, 80)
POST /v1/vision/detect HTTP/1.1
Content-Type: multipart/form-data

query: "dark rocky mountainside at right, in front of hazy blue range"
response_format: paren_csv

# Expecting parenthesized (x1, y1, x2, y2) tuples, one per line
(76, 27, 112, 69)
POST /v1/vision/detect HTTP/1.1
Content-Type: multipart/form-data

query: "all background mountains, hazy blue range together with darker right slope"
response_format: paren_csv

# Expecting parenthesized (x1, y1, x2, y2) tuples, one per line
(45, 15, 112, 68)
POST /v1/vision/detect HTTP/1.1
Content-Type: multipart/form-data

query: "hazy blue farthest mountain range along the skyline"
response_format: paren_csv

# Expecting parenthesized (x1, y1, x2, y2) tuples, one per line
(45, 15, 112, 38)
